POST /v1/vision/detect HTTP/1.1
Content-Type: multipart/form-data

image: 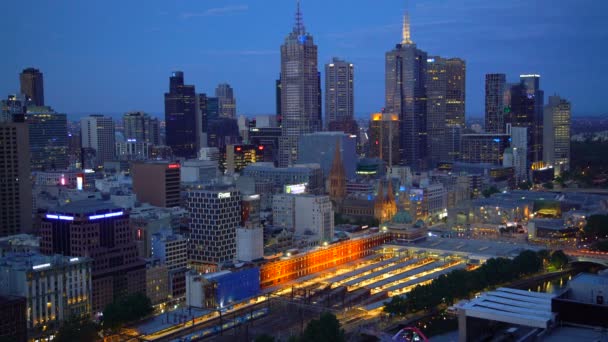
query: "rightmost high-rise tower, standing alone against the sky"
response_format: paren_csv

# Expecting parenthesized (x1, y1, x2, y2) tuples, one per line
(543, 95, 572, 172)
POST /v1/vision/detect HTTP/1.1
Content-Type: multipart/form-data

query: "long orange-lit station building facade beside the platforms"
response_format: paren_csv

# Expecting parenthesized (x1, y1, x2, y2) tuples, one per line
(260, 233, 390, 288)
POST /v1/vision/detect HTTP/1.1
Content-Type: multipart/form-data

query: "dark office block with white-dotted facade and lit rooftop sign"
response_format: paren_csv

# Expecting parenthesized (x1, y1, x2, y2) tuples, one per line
(186, 187, 241, 272)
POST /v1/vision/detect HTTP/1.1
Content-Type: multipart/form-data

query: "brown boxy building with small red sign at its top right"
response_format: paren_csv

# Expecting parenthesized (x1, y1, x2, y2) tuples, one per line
(131, 161, 181, 208)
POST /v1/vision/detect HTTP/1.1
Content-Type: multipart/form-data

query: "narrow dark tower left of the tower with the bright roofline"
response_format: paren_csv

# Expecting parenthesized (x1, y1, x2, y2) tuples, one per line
(485, 74, 509, 133)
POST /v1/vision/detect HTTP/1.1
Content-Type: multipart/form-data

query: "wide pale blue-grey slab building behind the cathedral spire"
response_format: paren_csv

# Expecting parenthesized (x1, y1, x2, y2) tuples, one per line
(298, 132, 357, 179)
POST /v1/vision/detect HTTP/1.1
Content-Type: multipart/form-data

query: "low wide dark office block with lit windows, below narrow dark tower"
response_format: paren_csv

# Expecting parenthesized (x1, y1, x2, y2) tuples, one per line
(460, 134, 511, 165)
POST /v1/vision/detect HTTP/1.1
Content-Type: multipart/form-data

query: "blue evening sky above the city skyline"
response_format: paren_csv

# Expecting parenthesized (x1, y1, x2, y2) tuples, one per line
(0, 0, 608, 117)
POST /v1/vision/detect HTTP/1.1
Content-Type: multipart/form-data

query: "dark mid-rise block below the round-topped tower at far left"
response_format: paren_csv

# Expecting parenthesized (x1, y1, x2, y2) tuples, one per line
(25, 106, 68, 171)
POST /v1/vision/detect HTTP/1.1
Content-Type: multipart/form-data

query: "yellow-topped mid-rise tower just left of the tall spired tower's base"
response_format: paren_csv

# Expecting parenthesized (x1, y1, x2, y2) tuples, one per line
(369, 113, 401, 165)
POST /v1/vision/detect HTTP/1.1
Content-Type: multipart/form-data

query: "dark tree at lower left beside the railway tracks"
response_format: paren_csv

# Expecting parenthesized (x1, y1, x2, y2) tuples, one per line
(103, 292, 154, 329)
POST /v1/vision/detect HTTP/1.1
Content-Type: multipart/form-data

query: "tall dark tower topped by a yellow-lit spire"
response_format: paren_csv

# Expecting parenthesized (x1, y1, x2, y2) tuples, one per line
(385, 13, 427, 169)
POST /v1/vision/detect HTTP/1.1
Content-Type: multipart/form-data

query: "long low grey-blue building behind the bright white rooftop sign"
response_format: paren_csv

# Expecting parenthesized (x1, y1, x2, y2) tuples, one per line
(242, 163, 325, 194)
